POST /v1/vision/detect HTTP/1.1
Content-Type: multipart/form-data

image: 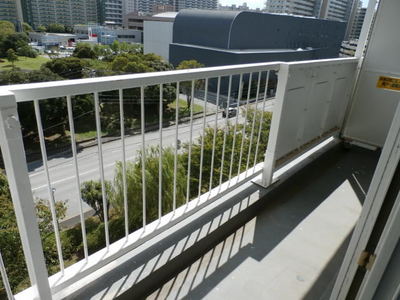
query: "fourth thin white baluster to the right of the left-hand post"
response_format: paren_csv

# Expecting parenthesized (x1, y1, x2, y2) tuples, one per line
(119, 89, 129, 238)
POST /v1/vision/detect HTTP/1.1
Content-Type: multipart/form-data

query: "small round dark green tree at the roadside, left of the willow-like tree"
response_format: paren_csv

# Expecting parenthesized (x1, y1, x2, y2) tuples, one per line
(81, 180, 112, 222)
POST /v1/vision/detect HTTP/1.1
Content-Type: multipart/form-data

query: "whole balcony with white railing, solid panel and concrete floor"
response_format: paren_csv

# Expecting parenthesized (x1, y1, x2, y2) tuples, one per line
(0, 58, 372, 299)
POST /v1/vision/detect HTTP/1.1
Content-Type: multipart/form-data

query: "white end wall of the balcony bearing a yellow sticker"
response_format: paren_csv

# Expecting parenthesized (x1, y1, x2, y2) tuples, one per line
(344, 0, 400, 147)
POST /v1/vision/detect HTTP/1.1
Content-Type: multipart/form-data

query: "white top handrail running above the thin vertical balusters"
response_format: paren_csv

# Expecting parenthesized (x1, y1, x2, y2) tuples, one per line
(0, 62, 283, 102)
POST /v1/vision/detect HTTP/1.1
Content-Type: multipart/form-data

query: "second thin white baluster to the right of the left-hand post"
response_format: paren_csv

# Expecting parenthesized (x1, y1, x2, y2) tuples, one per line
(67, 96, 88, 260)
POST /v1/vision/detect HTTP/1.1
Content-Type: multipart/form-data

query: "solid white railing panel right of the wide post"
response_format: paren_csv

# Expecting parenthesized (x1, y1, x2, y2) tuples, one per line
(271, 60, 357, 166)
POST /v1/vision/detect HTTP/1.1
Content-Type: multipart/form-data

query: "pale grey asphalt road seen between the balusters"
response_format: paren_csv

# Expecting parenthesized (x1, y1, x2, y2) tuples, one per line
(28, 101, 273, 225)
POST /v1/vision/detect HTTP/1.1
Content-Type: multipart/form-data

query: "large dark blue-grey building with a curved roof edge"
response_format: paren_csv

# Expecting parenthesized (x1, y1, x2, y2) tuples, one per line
(148, 10, 346, 66)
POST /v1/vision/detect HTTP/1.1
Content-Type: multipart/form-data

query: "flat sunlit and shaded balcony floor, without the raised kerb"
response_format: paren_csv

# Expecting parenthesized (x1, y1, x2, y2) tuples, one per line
(148, 146, 377, 300)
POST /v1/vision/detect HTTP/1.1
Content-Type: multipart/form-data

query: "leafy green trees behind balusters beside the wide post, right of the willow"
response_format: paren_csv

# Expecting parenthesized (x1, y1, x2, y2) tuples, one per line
(182, 108, 272, 198)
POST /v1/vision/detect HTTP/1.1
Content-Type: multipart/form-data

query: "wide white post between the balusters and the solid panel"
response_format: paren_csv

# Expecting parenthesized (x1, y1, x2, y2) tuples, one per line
(261, 63, 289, 187)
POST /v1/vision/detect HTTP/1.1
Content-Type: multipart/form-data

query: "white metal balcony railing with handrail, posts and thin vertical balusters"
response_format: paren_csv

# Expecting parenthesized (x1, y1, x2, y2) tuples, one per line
(0, 58, 358, 298)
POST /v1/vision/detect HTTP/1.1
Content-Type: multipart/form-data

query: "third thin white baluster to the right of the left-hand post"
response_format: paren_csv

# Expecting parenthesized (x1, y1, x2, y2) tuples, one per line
(94, 92, 110, 250)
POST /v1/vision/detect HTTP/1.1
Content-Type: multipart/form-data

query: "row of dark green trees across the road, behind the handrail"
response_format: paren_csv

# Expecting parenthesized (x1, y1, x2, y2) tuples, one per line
(0, 49, 202, 154)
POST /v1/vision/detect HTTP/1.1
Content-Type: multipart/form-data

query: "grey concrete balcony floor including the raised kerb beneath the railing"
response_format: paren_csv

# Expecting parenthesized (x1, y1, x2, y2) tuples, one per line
(65, 145, 379, 300)
